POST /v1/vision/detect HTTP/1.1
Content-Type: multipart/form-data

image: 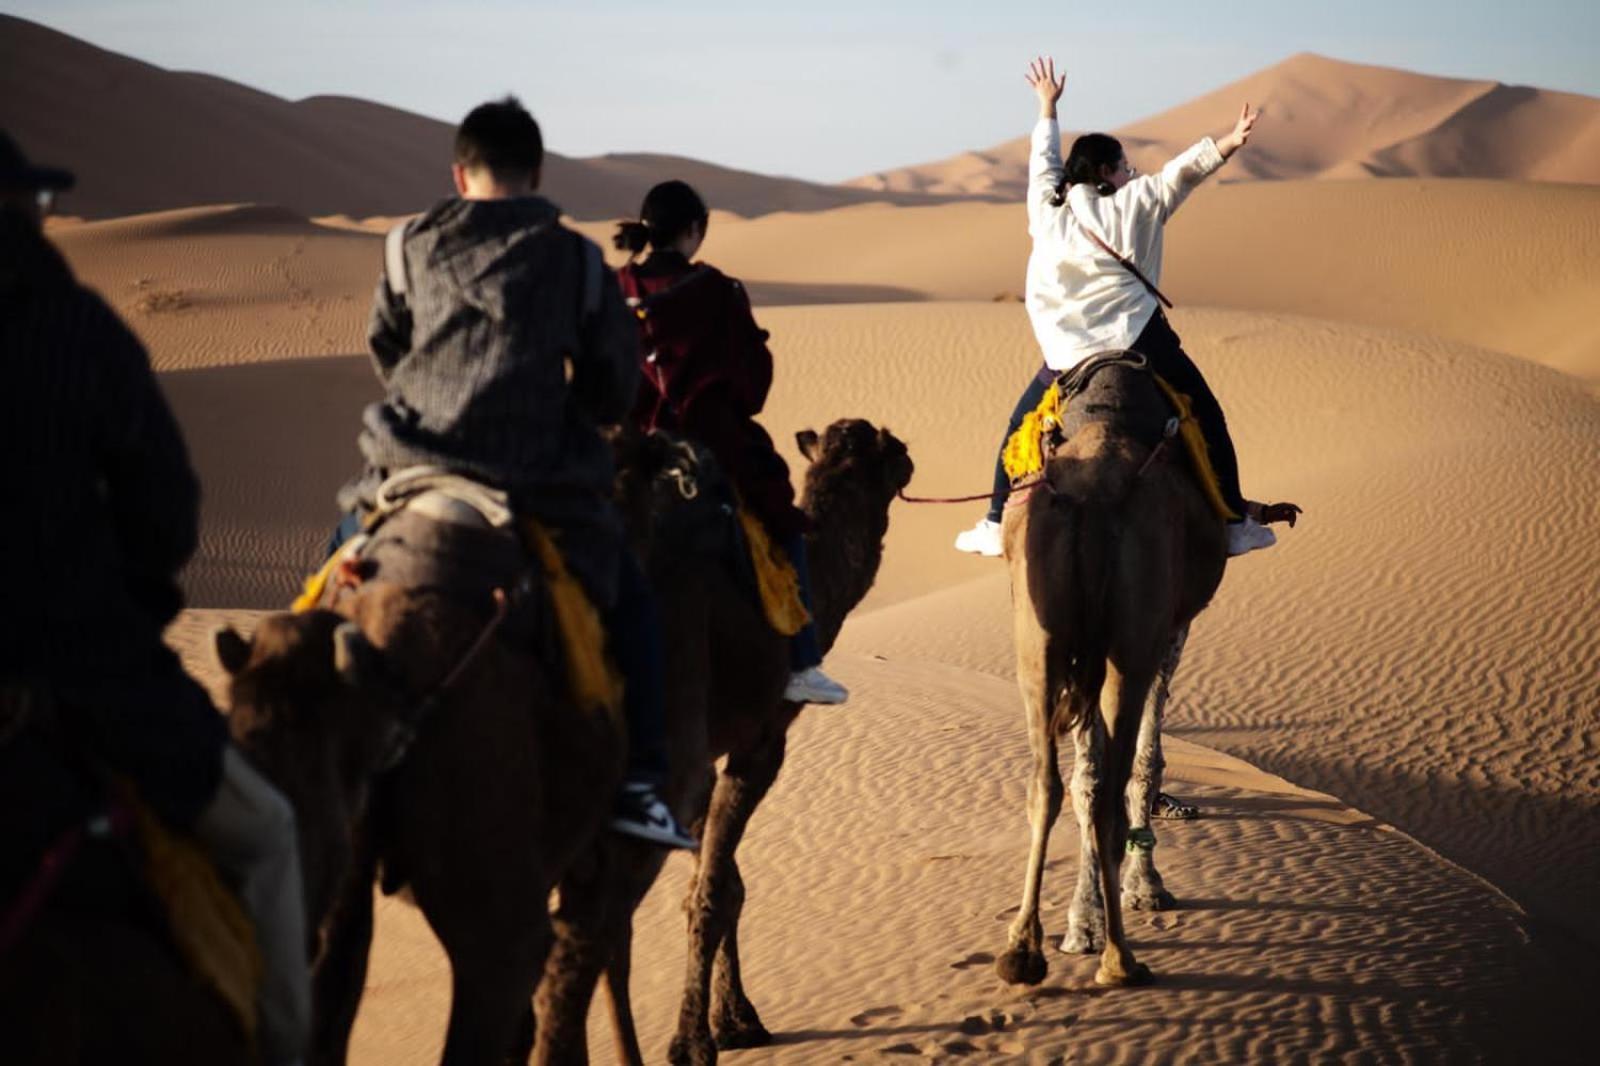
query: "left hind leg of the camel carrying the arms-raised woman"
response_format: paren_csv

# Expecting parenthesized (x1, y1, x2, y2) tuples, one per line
(995, 664, 1062, 984)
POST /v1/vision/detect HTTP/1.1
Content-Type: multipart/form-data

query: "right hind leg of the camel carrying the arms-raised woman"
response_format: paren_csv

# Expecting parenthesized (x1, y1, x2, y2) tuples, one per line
(1093, 663, 1155, 986)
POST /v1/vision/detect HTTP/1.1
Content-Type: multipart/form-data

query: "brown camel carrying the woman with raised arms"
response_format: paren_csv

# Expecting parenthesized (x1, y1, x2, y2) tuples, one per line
(995, 365, 1227, 986)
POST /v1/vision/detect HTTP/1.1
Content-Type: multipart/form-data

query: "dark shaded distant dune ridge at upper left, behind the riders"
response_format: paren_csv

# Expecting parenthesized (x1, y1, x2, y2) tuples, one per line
(0, 14, 966, 218)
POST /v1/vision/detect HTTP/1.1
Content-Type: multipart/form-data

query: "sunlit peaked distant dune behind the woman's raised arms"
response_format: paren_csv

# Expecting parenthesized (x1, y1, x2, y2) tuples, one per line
(845, 53, 1600, 198)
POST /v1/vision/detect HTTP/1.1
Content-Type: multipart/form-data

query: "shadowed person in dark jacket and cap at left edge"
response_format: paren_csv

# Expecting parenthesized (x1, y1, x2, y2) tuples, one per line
(0, 133, 310, 1064)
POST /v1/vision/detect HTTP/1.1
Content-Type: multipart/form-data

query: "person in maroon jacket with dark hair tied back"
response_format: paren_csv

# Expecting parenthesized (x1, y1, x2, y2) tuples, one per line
(616, 181, 850, 703)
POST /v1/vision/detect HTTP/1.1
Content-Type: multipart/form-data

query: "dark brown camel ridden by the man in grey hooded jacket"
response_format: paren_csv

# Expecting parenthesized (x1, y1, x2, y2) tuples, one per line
(218, 502, 622, 1066)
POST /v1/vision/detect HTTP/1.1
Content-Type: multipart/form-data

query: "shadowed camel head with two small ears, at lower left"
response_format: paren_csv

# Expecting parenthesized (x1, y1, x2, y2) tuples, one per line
(214, 610, 403, 940)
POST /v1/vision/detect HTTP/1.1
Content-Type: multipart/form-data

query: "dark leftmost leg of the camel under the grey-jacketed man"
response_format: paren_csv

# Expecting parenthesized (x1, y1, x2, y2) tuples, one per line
(310, 826, 378, 1066)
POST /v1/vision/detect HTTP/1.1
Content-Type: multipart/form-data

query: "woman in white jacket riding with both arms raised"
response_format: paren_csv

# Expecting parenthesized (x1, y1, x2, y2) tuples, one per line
(955, 59, 1277, 555)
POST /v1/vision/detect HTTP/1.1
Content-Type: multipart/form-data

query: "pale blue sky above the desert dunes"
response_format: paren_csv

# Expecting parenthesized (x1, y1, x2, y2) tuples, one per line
(12, 0, 1600, 181)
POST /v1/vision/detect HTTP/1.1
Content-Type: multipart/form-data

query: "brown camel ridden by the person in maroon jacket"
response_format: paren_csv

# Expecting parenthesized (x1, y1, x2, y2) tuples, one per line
(541, 419, 912, 1064)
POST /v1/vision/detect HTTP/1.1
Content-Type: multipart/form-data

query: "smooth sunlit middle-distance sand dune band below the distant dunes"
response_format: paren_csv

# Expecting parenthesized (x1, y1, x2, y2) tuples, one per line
(53, 179, 1600, 384)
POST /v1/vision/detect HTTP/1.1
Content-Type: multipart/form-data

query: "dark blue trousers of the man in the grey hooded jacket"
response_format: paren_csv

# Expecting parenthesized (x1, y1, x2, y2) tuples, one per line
(328, 511, 668, 787)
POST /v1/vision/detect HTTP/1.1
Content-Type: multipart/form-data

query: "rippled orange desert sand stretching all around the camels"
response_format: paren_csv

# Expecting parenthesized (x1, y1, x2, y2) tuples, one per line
(15, 12, 1600, 1064)
